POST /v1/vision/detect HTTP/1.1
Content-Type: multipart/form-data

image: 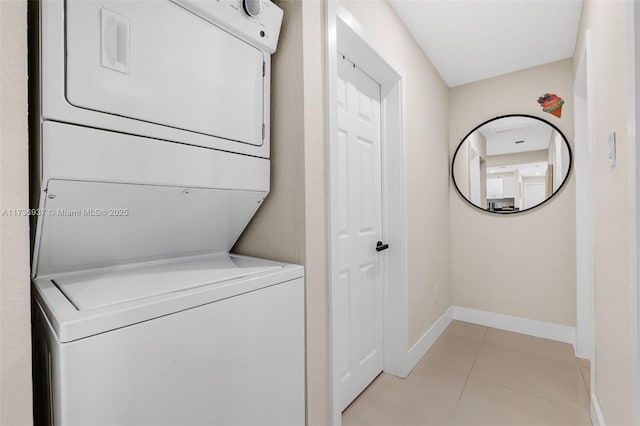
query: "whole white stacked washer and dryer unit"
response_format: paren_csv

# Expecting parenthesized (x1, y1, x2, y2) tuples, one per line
(32, 0, 305, 426)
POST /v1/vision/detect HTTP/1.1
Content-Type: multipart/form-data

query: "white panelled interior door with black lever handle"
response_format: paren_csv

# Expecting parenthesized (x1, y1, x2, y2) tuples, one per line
(332, 54, 384, 410)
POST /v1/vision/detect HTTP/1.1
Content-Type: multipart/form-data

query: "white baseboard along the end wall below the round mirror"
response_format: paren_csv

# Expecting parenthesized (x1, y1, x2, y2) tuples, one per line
(452, 306, 576, 345)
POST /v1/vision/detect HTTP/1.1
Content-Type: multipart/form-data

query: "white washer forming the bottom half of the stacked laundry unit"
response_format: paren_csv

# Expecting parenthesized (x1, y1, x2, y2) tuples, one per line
(34, 254, 304, 426)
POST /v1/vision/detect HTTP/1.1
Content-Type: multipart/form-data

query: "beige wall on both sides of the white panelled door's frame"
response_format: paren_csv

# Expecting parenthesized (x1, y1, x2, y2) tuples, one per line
(234, 0, 451, 425)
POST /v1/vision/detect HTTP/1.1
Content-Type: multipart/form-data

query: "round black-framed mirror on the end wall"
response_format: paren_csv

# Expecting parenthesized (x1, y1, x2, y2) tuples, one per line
(451, 114, 572, 214)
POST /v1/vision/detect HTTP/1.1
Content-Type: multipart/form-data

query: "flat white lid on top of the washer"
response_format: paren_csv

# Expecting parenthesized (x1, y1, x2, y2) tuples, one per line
(51, 253, 284, 311)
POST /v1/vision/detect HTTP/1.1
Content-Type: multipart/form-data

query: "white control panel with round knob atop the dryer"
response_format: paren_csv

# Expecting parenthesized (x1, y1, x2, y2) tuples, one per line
(171, 0, 284, 53)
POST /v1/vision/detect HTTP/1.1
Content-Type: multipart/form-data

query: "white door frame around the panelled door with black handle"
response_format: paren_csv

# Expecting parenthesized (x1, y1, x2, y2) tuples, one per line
(325, 0, 409, 426)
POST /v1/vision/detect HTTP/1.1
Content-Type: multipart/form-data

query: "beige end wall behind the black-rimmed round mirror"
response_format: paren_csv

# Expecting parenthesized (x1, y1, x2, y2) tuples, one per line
(449, 59, 576, 326)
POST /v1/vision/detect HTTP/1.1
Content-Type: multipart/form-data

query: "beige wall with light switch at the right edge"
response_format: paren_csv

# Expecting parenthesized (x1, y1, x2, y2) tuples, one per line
(574, 1, 638, 425)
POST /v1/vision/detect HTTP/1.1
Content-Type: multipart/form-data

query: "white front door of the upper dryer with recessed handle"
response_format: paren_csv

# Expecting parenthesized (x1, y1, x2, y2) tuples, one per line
(65, 0, 265, 146)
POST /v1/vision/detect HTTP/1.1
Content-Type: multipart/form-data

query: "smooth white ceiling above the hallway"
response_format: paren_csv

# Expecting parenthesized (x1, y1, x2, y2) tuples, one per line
(389, 0, 582, 87)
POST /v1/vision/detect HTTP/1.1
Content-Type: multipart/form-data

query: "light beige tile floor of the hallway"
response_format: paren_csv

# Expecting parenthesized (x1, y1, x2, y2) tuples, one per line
(342, 321, 591, 426)
